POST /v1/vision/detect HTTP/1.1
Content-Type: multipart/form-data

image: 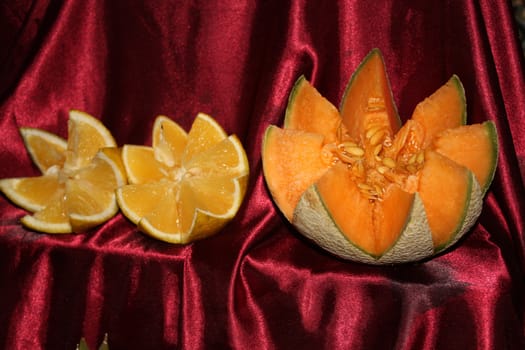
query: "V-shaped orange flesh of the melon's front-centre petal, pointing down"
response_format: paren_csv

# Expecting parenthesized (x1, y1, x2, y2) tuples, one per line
(316, 164, 414, 257)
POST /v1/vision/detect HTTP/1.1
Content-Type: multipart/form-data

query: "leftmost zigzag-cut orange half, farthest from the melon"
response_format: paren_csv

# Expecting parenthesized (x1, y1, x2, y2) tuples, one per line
(0, 111, 126, 233)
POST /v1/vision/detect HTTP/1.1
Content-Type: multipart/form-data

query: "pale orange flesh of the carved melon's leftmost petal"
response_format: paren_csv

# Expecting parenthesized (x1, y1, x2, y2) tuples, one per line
(262, 126, 328, 221)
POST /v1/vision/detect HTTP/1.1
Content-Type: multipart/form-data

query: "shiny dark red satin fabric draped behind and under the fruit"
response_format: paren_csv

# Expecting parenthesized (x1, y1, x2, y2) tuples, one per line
(0, 0, 525, 350)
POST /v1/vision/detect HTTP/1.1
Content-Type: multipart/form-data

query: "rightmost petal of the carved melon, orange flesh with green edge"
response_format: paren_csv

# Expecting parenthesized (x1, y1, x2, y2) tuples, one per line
(433, 121, 498, 193)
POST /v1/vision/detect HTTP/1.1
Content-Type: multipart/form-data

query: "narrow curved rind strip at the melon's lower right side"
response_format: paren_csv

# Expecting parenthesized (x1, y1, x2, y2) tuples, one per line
(435, 170, 483, 254)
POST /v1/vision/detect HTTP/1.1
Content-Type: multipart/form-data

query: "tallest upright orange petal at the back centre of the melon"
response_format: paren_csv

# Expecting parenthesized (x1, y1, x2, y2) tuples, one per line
(339, 49, 401, 140)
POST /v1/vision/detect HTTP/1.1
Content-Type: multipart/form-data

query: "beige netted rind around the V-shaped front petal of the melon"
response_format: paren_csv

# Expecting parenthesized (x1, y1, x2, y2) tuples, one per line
(292, 185, 434, 265)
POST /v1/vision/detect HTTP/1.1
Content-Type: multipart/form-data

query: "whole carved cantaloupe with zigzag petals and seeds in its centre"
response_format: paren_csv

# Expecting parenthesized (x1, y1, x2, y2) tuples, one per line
(262, 49, 498, 265)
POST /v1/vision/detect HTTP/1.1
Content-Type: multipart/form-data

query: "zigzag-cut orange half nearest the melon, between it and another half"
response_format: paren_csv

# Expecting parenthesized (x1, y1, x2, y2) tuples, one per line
(117, 113, 249, 244)
